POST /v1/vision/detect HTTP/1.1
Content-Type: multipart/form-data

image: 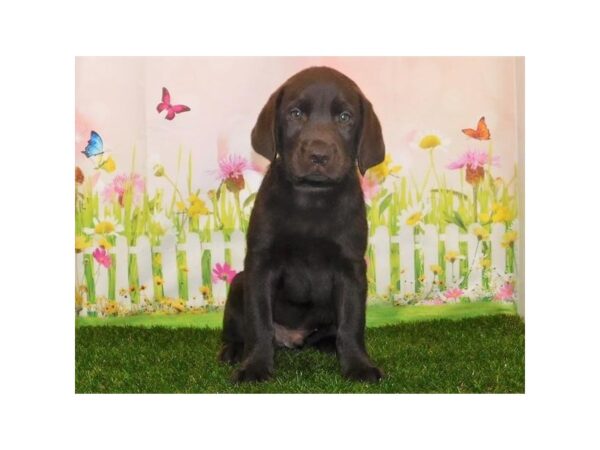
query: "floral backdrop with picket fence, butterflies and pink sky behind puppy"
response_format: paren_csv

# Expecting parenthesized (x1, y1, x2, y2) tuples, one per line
(75, 57, 523, 316)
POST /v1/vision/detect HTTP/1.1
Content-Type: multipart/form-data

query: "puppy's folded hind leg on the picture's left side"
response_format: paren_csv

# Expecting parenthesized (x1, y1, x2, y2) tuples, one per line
(219, 272, 244, 364)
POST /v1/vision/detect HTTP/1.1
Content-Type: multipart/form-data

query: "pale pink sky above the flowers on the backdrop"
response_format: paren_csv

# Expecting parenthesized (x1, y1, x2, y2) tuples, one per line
(75, 57, 523, 191)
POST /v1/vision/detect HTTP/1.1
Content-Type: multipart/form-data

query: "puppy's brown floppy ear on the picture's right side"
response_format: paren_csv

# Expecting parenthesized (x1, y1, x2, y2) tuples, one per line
(357, 93, 385, 175)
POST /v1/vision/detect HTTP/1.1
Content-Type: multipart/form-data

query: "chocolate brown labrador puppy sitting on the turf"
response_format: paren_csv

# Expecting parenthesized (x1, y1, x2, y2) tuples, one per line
(220, 67, 385, 381)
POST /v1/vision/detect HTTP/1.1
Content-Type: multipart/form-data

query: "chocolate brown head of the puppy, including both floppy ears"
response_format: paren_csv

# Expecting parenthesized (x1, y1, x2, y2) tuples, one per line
(252, 67, 385, 187)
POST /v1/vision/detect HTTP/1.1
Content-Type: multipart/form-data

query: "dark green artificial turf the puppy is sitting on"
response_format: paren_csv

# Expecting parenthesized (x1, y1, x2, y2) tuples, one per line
(75, 314, 525, 393)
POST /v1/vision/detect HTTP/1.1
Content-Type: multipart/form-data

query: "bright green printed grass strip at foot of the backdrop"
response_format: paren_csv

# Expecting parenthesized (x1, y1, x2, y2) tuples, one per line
(76, 302, 516, 328)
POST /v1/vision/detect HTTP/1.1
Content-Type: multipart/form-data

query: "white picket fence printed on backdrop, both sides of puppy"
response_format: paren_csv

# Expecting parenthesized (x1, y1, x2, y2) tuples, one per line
(76, 222, 516, 307)
